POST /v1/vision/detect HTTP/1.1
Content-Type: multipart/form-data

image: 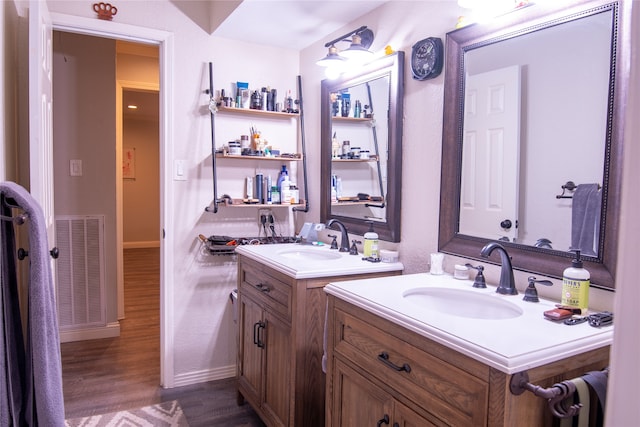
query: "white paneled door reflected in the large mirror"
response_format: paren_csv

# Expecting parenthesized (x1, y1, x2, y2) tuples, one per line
(459, 66, 520, 241)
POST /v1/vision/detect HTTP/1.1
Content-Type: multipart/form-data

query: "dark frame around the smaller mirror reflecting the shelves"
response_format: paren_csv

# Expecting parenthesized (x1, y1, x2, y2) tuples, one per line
(320, 51, 404, 242)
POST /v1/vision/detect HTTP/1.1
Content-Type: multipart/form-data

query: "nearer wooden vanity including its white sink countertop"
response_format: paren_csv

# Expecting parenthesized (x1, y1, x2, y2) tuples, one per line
(325, 274, 613, 427)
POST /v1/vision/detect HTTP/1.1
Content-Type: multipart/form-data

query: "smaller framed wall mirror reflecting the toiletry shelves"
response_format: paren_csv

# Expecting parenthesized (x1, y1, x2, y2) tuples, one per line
(320, 52, 404, 242)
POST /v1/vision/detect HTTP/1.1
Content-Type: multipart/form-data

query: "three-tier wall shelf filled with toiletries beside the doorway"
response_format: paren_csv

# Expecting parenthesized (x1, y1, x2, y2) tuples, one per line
(205, 69, 309, 213)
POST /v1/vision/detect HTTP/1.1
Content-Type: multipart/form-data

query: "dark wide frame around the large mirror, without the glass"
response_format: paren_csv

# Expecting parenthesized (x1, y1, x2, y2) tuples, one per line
(438, 0, 630, 290)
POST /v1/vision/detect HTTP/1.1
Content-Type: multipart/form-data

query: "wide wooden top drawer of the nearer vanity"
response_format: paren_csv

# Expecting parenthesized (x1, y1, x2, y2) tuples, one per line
(334, 310, 489, 427)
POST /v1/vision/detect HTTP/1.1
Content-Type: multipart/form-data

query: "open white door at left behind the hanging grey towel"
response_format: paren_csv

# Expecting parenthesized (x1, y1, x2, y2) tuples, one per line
(29, 0, 55, 252)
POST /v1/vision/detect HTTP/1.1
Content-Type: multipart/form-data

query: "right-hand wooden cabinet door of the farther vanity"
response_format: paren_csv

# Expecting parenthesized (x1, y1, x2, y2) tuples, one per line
(263, 311, 293, 426)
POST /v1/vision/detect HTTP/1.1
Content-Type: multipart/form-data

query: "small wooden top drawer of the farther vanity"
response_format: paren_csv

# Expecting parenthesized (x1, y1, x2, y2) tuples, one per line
(240, 264, 292, 321)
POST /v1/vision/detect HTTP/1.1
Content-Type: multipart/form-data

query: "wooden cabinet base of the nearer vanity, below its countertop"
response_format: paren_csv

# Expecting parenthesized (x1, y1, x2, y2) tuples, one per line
(326, 296, 609, 427)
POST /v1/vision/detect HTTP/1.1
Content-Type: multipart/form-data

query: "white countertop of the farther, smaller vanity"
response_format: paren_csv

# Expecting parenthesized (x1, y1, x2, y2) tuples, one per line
(236, 243, 404, 279)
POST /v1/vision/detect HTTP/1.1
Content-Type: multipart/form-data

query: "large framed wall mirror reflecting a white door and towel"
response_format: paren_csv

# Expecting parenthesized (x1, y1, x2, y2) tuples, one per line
(439, 0, 627, 289)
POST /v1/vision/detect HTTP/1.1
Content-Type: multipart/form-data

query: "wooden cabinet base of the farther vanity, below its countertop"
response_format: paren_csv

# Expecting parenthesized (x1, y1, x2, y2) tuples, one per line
(237, 255, 401, 427)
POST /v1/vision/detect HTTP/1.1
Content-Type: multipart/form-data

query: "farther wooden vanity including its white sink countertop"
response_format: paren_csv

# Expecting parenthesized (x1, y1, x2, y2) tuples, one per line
(236, 244, 403, 426)
